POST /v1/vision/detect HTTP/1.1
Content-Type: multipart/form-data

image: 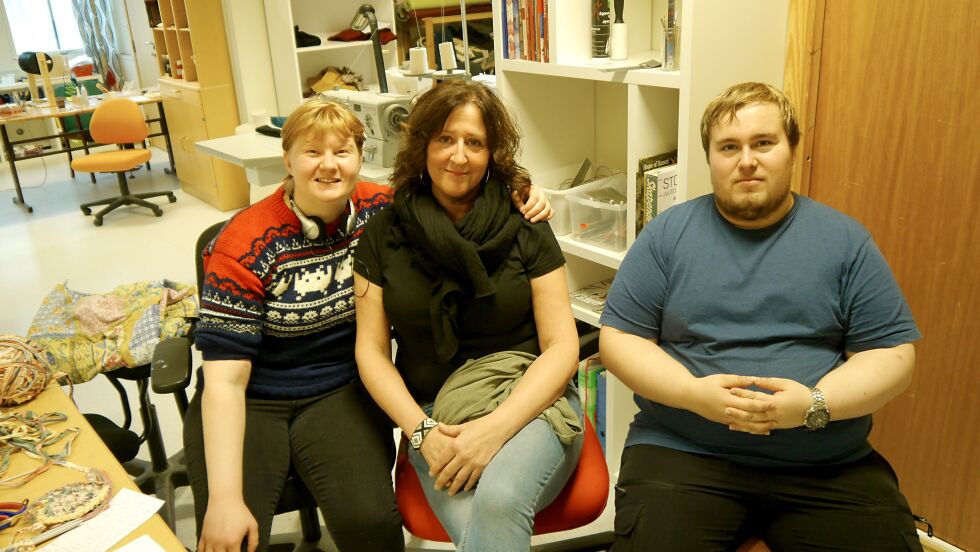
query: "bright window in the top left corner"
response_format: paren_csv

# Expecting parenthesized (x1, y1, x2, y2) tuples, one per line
(3, 0, 84, 53)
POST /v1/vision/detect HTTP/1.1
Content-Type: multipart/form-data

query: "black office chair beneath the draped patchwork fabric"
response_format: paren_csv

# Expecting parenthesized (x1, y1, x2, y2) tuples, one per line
(85, 364, 189, 529)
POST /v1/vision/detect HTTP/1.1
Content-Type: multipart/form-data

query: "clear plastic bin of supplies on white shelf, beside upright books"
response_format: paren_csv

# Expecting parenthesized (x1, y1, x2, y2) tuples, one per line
(568, 173, 626, 251)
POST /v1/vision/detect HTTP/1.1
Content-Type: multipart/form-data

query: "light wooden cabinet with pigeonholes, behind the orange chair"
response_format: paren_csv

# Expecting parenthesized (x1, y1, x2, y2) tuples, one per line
(146, 0, 249, 211)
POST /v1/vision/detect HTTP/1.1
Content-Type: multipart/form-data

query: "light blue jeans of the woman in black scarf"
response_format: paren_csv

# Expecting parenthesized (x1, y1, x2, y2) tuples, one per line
(408, 386, 583, 552)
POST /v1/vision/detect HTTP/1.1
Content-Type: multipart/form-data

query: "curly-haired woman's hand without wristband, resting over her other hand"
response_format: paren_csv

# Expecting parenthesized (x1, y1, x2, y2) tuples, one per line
(436, 417, 510, 496)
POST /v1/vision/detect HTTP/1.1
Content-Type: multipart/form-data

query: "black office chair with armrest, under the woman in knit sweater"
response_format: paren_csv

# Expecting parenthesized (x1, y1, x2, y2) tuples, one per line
(152, 222, 322, 542)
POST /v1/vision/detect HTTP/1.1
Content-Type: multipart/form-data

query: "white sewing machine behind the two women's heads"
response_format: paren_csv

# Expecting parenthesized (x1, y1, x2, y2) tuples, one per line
(320, 90, 411, 167)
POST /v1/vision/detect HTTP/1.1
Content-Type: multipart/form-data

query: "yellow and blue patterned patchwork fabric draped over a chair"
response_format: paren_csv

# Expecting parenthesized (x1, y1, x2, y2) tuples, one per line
(27, 280, 197, 383)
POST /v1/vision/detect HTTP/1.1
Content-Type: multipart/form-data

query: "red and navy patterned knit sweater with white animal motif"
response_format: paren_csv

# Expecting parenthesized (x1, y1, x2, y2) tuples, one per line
(194, 182, 391, 399)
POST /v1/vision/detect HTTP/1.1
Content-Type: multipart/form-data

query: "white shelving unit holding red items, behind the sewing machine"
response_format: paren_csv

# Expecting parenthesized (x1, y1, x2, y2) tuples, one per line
(265, 0, 398, 115)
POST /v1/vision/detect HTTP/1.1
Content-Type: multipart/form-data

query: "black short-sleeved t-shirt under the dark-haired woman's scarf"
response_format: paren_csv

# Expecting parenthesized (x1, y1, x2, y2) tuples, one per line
(354, 205, 565, 401)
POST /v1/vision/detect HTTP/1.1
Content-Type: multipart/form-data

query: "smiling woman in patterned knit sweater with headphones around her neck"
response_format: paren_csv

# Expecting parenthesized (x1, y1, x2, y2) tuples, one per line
(184, 98, 551, 552)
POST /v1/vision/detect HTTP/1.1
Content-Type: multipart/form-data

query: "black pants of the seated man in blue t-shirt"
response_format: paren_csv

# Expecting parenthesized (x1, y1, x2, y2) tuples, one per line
(613, 445, 922, 552)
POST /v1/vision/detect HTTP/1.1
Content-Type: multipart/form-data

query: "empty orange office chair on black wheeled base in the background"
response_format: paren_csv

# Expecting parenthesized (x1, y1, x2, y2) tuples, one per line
(71, 98, 177, 226)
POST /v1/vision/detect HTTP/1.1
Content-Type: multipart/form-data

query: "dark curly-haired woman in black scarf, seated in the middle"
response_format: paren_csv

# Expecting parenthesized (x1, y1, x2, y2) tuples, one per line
(354, 81, 582, 552)
